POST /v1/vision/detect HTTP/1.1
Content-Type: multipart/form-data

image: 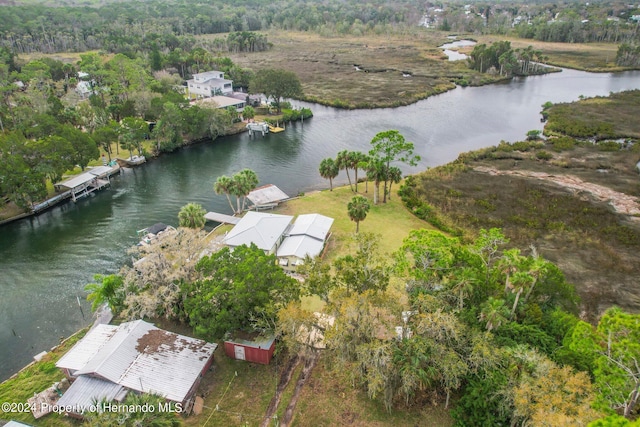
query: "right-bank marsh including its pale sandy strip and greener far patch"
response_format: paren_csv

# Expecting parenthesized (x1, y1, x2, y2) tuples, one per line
(402, 91, 640, 321)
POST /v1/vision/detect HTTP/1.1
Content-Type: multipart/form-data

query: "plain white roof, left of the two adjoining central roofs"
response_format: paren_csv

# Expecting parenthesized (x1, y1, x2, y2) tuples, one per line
(224, 211, 293, 251)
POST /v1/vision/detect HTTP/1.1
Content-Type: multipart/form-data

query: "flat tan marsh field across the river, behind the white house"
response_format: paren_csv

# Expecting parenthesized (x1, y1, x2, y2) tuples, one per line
(230, 31, 497, 108)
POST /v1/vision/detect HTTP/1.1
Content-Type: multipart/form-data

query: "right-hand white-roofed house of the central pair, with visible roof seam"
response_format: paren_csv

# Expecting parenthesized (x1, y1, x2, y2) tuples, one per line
(277, 214, 333, 271)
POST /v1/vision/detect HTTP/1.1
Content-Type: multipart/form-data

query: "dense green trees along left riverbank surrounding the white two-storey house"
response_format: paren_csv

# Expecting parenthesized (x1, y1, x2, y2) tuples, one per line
(0, 48, 252, 209)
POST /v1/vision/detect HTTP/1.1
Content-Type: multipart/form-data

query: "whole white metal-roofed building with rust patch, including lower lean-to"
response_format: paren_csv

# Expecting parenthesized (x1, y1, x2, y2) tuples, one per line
(56, 320, 217, 415)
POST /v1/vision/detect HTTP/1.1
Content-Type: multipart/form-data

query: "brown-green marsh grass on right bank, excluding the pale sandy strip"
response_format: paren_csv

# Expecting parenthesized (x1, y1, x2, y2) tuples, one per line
(404, 141, 640, 318)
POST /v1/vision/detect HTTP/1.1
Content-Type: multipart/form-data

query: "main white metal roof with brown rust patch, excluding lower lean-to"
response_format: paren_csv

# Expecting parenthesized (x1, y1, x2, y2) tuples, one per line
(61, 320, 217, 402)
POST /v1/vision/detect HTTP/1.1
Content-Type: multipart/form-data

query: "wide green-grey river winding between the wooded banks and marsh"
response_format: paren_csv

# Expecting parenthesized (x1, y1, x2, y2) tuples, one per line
(0, 70, 640, 380)
